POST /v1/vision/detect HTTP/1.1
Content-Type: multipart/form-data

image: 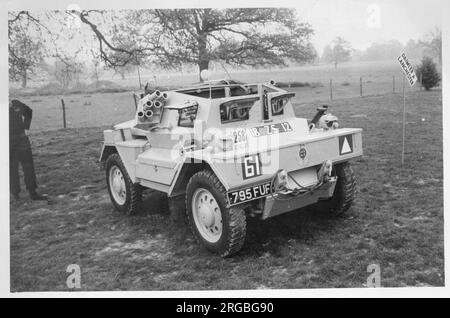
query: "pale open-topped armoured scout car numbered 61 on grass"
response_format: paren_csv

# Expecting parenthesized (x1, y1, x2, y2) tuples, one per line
(100, 80, 363, 256)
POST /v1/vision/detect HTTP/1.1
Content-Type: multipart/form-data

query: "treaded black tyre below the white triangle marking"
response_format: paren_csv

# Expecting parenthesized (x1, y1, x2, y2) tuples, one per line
(316, 162, 356, 217)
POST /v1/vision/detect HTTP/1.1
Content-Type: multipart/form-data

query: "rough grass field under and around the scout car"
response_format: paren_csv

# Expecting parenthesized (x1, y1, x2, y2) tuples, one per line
(10, 90, 444, 291)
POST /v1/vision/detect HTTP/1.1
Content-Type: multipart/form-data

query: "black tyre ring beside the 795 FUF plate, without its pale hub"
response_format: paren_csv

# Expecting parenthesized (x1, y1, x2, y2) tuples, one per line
(186, 170, 247, 257)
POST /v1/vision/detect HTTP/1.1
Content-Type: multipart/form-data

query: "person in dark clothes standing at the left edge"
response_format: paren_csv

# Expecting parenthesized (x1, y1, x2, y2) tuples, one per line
(9, 99, 47, 201)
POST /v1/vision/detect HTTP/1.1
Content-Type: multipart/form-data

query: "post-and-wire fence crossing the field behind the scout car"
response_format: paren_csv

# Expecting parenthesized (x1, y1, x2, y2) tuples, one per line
(23, 73, 432, 131)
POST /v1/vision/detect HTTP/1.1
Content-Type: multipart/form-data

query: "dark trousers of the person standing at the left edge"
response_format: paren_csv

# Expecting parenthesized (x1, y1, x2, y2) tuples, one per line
(9, 135, 37, 195)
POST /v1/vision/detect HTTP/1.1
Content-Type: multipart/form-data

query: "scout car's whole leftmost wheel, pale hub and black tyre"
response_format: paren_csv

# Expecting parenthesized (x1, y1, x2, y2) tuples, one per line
(105, 153, 142, 215)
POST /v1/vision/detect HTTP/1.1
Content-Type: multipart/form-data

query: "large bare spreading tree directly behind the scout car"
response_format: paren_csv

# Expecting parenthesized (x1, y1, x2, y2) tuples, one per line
(76, 8, 314, 80)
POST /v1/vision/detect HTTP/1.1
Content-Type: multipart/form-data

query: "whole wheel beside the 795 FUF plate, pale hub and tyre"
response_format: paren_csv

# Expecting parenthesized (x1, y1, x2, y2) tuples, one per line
(186, 170, 246, 257)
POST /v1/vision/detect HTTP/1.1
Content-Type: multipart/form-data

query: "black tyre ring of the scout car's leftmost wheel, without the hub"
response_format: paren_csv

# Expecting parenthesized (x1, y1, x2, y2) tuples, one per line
(105, 153, 142, 215)
